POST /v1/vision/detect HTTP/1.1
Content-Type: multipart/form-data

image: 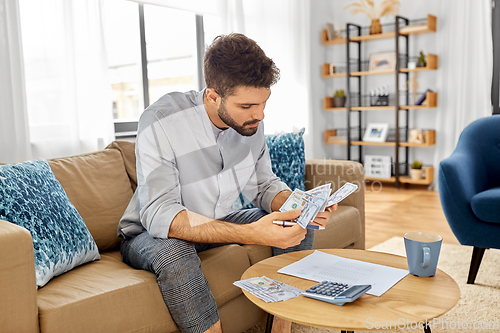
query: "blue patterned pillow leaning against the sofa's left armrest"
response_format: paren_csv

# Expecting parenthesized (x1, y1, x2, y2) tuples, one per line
(0, 161, 100, 287)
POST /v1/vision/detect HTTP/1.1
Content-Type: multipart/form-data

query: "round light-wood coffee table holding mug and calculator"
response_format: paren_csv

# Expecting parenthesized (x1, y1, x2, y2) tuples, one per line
(241, 249, 460, 332)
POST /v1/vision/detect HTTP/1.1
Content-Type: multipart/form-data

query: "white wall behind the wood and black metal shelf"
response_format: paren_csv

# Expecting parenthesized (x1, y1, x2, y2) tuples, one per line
(309, 0, 442, 169)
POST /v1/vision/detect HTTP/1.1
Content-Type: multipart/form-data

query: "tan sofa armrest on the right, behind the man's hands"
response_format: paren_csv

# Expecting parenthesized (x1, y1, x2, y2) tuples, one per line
(304, 159, 365, 249)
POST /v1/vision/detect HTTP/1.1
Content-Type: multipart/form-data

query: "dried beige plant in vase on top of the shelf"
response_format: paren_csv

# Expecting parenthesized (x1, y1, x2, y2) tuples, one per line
(344, 0, 400, 35)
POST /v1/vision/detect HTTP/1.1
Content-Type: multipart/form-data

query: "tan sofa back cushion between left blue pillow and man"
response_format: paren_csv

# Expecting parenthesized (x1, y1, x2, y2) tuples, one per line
(49, 149, 133, 251)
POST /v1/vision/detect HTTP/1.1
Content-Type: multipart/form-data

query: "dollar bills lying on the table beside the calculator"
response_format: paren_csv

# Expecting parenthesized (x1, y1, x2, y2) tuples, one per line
(233, 276, 302, 303)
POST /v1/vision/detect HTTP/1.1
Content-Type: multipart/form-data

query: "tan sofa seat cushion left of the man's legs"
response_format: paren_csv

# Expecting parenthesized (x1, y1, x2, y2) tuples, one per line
(38, 252, 178, 333)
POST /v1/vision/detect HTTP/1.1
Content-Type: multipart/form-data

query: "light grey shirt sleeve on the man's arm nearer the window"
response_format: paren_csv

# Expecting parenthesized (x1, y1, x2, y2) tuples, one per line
(136, 113, 186, 238)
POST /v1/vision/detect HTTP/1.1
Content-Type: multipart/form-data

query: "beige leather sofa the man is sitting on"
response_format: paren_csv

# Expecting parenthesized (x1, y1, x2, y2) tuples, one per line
(0, 141, 365, 333)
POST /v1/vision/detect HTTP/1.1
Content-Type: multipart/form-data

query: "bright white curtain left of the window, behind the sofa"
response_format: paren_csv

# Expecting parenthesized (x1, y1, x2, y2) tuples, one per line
(14, 0, 114, 158)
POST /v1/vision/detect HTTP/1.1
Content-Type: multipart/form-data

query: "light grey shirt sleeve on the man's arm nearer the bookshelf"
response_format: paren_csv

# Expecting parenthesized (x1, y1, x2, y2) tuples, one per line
(242, 139, 290, 213)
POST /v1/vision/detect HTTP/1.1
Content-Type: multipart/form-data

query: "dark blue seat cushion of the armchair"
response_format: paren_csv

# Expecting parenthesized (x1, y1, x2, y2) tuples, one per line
(470, 187, 500, 223)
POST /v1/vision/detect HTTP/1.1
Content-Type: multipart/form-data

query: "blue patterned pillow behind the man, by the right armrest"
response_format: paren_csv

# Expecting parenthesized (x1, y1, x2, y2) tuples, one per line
(266, 128, 306, 191)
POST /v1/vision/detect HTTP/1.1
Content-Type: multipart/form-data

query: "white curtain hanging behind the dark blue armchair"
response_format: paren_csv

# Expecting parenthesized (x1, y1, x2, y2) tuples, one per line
(434, 0, 492, 183)
